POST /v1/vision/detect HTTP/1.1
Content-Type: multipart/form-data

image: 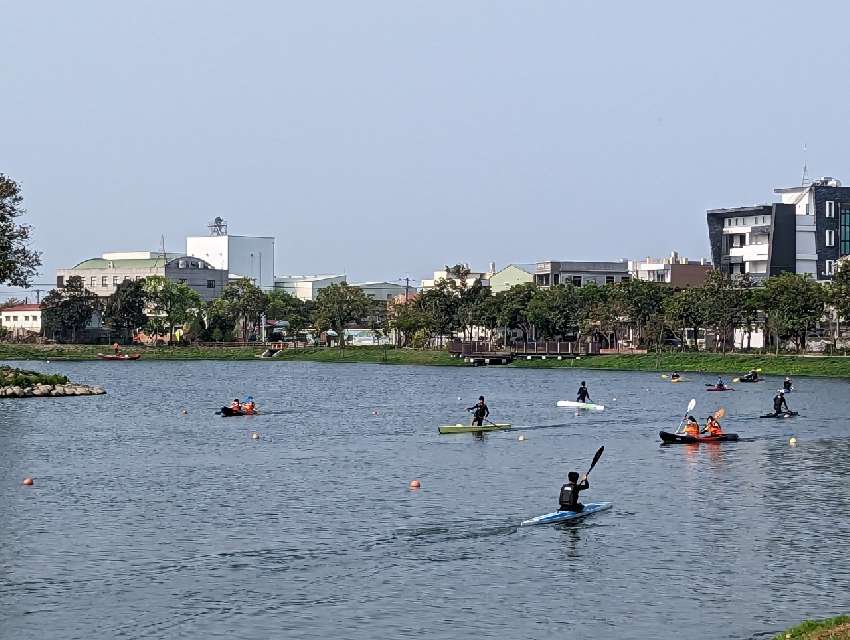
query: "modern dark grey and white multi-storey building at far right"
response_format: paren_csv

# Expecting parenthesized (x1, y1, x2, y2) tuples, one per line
(706, 178, 850, 280)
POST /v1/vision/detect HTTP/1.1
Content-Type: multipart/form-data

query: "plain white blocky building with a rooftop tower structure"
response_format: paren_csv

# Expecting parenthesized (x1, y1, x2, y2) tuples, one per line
(186, 218, 275, 290)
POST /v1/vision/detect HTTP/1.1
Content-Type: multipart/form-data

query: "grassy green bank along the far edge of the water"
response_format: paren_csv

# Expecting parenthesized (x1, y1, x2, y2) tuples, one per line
(0, 344, 850, 379)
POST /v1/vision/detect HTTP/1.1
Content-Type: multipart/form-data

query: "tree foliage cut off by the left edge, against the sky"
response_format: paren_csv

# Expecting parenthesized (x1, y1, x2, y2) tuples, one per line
(0, 173, 41, 287)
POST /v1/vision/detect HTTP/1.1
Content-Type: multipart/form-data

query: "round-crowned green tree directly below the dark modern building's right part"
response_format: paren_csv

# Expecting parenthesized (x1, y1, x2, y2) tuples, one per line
(761, 273, 825, 353)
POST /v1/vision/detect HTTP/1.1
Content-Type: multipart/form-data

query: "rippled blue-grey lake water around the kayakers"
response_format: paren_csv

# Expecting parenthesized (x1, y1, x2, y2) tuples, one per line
(0, 361, 850, 640)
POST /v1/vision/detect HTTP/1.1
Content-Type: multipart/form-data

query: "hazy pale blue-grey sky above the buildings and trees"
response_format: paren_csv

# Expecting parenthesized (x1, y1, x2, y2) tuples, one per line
(0, 0, 850, 294)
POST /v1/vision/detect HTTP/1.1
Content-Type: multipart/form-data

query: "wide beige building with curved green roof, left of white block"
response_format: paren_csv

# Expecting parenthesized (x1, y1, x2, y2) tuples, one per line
(56, 251, 227, 302)
